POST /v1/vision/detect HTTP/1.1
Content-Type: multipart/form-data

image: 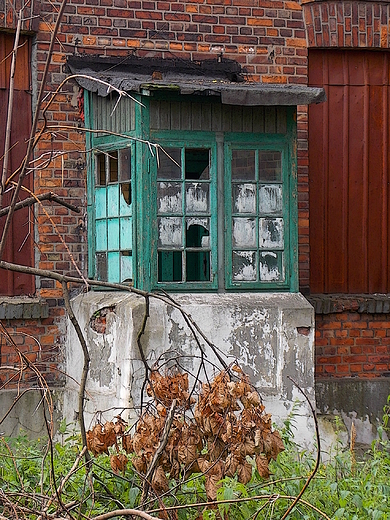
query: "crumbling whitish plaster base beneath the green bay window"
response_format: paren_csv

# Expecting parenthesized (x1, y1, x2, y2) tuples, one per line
(63, 292, 314, 444)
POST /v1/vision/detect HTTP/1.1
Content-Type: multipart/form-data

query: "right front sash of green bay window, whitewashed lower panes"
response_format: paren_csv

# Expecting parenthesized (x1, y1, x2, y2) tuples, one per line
(225, 143, 288, 288)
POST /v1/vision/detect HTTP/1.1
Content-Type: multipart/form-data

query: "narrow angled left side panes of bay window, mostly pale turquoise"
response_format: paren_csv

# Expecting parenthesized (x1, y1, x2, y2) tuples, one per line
(95, 148, 133, 283)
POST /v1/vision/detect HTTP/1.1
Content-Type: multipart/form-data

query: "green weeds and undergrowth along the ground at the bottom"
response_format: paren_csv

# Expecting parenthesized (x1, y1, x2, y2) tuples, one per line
(0, 417, 390, 520)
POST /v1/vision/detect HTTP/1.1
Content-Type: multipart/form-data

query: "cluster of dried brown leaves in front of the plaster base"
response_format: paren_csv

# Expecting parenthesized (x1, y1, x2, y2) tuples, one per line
(87, 366, 284, 500)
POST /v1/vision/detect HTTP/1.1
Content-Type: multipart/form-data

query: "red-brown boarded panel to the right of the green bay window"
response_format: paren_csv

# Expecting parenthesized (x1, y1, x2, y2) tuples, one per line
(309, 49, 390, 294)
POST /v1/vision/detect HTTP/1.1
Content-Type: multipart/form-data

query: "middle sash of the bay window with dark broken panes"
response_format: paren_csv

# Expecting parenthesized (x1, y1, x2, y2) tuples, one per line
(157, 145, 216, 286)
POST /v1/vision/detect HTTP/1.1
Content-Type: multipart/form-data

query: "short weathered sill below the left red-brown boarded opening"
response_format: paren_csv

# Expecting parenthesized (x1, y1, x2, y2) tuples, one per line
(0, 296, 49, 320)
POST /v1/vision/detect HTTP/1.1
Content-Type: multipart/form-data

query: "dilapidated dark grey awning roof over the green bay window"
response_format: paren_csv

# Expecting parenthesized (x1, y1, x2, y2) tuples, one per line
(67, 55, 326, 106)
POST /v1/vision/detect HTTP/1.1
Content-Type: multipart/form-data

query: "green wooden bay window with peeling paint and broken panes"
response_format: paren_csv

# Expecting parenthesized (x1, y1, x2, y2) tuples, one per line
(90, 96, 297, 291)
